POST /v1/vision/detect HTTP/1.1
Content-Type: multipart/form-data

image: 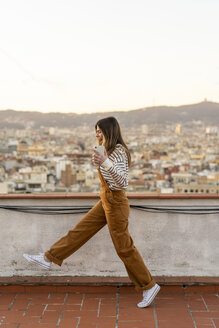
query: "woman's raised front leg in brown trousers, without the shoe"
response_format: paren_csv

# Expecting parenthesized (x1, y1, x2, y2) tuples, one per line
(45, 200, 106, 266)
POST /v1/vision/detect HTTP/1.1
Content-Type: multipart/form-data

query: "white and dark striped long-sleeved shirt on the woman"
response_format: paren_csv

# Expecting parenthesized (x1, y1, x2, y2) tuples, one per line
(100, 144, 128, 190)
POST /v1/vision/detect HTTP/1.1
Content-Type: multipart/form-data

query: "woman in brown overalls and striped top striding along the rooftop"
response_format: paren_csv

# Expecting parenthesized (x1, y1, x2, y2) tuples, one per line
(24, 117, 160, 308)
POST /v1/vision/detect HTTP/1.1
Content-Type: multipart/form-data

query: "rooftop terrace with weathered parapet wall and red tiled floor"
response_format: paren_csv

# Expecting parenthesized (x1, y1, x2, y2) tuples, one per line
(0, 194, 219, 328)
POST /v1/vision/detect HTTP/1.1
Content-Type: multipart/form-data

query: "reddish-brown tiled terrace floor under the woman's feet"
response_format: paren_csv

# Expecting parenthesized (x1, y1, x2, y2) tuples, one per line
(0, 286, 219, 328)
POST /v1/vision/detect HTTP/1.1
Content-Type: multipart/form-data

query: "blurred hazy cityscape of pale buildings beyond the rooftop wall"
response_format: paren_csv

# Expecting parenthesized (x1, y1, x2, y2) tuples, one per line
(0, 116, 219, 194)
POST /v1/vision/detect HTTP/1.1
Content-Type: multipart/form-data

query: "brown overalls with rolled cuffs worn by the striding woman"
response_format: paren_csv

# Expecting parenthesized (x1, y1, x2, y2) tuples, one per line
(45, 170, 155, 291)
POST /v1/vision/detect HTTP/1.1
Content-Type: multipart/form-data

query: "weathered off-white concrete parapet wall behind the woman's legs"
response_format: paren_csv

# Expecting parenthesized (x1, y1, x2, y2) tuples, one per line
(0, 199, 219, 277)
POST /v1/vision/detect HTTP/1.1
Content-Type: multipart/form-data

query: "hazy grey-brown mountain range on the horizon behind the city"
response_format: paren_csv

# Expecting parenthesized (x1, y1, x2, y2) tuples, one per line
(0, 101, 219, 129)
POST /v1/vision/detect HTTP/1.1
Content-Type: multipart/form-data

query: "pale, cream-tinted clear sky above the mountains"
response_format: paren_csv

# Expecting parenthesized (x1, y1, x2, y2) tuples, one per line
(0, 0, 219, 113)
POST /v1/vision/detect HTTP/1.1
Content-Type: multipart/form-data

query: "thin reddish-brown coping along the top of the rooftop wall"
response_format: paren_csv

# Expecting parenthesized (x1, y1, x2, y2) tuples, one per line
(0, 192, 219, 199)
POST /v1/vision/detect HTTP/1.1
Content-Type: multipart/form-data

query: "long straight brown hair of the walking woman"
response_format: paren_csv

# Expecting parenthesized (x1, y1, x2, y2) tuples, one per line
(95, 116, 131, 166)
